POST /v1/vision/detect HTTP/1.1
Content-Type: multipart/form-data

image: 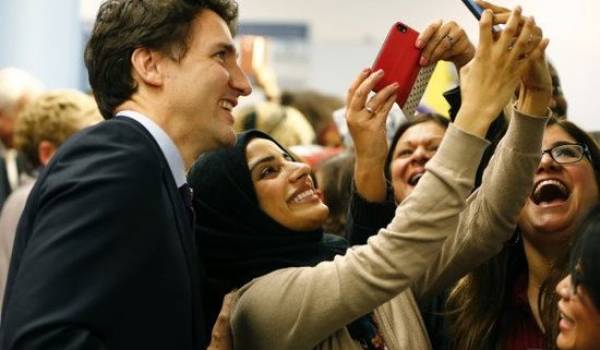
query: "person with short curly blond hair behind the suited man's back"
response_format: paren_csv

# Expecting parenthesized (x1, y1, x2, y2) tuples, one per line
(0, 90, 102, 310)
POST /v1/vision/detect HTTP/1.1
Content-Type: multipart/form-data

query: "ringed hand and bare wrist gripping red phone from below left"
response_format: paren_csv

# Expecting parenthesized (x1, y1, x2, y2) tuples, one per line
(346, 69, 399, 201)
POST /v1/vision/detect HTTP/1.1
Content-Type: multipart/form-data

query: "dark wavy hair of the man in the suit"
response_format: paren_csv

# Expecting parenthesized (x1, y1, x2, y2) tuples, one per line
(85, 0, 238, 119)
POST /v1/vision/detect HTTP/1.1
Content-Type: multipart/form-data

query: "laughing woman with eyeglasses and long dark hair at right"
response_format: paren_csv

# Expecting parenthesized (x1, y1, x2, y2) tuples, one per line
(448, 119, 600, 350)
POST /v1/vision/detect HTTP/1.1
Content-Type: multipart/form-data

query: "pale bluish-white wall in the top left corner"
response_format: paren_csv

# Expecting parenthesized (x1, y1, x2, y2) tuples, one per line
(0, 0, 83, 88)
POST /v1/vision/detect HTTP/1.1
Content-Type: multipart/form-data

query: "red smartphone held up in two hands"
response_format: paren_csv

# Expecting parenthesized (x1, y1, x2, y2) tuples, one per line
(372, 22, 421, 107)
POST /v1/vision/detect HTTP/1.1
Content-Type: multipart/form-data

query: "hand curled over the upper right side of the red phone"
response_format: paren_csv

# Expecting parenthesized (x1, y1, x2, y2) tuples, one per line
(416, 20, 475, 70)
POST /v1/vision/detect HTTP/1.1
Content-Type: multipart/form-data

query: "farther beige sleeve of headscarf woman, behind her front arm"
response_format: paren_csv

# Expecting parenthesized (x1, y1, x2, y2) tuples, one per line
(413, 110, 548, 299)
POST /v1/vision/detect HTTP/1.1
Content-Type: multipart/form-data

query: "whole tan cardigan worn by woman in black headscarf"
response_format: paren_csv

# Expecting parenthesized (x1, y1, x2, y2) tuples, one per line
(231, 115, 545, 350)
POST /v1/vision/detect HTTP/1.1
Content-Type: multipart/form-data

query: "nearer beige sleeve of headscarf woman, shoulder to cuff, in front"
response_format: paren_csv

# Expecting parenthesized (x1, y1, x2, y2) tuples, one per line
(232, 126, 488, 350)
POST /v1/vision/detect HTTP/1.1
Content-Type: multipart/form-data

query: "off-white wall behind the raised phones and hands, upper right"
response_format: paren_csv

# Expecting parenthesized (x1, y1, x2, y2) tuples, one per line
(239, 0, 600, 130)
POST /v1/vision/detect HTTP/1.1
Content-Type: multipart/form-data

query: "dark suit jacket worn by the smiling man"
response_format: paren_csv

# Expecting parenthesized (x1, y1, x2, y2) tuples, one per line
(0, 118, 207, 350)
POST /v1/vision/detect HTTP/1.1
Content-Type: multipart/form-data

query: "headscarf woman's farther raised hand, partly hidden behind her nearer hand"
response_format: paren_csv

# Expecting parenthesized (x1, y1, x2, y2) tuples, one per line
(477, 0, 552, 115)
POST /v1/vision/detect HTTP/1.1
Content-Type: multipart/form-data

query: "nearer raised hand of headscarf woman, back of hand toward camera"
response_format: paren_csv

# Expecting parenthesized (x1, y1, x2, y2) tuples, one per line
(455, 7, 548, 137)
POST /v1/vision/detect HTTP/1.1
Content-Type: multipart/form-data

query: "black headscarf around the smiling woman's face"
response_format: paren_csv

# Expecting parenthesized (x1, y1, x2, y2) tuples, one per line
(188, 130, 347, 324)
